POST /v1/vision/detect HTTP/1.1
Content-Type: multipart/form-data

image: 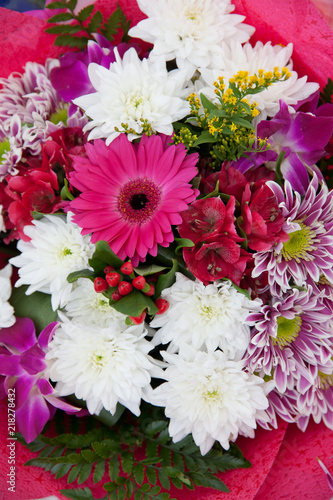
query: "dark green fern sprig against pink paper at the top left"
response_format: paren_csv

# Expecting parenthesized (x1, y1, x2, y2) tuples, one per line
(45, 0, 130, 50)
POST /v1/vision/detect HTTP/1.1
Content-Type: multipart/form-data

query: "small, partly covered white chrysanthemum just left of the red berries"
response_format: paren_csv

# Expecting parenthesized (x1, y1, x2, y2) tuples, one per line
(65, 279, 127, 329)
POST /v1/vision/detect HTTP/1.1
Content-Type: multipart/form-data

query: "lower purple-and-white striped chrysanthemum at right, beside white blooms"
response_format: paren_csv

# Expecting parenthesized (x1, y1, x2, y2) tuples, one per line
(246, 286, 333, 394)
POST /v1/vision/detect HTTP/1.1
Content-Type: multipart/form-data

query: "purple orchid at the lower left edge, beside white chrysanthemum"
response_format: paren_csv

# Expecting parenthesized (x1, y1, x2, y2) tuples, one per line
(0, 318, 80, 443)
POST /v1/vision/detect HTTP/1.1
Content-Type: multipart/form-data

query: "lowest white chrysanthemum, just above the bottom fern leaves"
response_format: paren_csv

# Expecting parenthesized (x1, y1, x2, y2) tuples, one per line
(152, 346, 274, 455)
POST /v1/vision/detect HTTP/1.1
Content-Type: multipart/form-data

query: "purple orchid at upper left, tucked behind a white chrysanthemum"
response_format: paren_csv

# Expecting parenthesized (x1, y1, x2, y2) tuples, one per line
(50, 35, 130, 102)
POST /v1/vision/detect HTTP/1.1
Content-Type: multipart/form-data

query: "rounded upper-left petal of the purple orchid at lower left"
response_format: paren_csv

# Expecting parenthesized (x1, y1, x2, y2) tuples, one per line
(0, 318, 37, 352)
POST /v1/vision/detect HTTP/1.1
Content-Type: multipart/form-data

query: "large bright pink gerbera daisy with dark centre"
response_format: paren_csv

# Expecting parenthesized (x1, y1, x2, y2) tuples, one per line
(69, 134, 198, 265)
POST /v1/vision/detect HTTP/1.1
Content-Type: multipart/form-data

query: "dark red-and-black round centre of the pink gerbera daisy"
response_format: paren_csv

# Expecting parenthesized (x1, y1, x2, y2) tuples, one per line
(118, 178, 162, 225)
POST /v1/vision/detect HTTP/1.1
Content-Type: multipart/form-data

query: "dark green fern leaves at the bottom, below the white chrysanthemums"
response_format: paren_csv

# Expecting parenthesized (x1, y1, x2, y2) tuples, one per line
(19, 404, 250, 500)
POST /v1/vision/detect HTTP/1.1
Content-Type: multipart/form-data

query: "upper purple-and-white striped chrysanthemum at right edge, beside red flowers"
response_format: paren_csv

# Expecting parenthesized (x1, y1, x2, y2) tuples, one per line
(252, 174, 333, 295)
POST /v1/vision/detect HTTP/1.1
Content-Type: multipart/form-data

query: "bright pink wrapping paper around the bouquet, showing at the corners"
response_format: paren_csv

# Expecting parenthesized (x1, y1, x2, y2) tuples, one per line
(0, 0, 333, 500)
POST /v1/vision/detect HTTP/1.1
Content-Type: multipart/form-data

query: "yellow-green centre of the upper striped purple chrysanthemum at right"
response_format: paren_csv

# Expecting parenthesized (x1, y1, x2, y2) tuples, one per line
(281, 221, 316, 263)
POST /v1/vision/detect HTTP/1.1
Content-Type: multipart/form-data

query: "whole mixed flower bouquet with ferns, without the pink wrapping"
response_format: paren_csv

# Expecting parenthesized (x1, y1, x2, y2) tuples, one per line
(0, 0, 333, 500)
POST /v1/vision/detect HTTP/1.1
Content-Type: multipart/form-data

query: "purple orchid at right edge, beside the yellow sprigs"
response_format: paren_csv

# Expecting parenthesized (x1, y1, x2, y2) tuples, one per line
(258, 101, 333, 195)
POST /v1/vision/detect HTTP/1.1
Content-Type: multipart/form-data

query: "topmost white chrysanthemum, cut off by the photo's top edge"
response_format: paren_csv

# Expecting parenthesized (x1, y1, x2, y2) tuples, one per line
(129, 0, 254, 78)
